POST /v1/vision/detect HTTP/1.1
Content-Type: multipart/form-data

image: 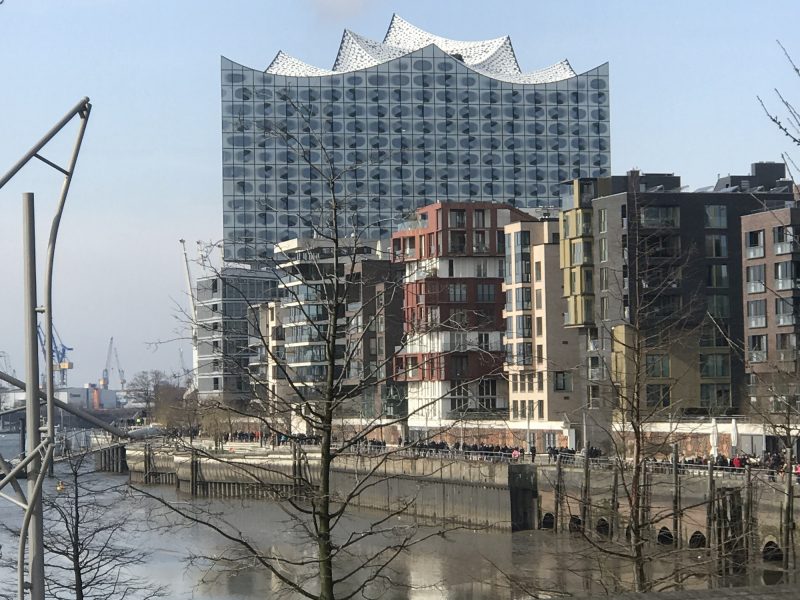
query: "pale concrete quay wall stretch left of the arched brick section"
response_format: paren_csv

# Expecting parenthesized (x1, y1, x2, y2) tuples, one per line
(122, 446, 538, 530)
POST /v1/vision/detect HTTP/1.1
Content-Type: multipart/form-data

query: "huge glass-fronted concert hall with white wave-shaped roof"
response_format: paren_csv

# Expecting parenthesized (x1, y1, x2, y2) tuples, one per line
(222, 15, 610, 263)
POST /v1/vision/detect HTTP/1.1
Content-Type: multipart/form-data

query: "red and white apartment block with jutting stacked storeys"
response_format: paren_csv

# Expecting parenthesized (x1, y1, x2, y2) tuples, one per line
(392, 202, 530, 438)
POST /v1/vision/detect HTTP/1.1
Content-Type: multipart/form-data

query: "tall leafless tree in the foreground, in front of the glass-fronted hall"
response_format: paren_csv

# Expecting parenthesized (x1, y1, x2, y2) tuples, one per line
(137, 92, 488, 600)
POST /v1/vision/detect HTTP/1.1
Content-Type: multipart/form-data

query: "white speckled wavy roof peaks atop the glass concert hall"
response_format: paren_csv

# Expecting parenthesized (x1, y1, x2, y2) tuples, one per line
(266, 15, 576, 83)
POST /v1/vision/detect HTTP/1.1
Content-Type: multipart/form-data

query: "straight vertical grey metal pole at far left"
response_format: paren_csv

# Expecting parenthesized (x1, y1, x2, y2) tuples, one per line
(20, 192, 44, 600)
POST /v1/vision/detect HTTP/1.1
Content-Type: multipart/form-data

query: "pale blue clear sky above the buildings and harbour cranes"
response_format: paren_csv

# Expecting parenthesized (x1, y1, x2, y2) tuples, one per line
(0, 0, 800, 387)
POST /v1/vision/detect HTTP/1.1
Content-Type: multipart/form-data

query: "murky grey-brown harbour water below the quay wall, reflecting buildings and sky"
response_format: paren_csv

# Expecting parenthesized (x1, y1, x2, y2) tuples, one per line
(0, 435, 792, 600)
